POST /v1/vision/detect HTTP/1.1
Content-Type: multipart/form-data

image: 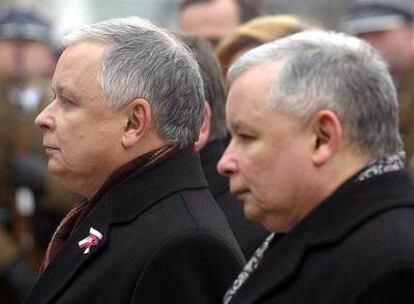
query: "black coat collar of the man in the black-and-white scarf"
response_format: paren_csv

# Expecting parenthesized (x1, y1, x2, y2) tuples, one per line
(236, 170, 414, 303)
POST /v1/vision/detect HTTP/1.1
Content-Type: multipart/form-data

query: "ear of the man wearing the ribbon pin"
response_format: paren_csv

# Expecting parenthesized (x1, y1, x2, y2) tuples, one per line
(122, 98, 152, 149)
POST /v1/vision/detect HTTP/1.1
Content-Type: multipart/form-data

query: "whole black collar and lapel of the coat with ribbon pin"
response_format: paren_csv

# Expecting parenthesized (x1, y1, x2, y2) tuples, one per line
(26, 152, 207, 303)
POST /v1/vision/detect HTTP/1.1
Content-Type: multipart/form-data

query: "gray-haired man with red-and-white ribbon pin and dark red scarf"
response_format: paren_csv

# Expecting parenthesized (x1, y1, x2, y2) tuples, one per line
(26, 17, 243, 303)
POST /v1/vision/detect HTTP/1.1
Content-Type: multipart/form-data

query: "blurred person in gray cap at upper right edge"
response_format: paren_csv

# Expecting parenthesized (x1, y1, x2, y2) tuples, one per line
(342, 0, 414, 171)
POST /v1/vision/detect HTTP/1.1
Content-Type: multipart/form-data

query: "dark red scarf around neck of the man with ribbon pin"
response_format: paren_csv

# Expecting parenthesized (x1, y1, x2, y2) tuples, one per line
(39, 146, 179, 274)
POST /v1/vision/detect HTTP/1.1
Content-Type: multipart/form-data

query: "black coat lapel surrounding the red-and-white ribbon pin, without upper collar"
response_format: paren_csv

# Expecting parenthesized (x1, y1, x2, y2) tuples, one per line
(26, 200, 110, 303)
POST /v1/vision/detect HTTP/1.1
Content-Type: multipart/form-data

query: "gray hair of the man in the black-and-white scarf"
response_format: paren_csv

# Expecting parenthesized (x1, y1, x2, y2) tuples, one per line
(228, 31, 402, 157)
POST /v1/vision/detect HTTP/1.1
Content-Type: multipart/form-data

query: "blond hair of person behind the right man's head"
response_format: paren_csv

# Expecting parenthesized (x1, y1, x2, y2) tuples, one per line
(216, 15, 312, 78)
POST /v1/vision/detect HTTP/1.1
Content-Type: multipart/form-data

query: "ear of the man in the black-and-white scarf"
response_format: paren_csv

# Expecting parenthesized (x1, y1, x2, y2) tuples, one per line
(309, 110, 343, 166)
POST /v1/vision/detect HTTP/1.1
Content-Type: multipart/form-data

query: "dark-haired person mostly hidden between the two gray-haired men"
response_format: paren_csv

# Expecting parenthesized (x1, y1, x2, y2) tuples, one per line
(181, 36, 269, 258)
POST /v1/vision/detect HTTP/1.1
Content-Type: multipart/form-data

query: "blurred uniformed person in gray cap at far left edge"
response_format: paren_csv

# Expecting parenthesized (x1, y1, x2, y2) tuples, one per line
(0, 7, 75, 303)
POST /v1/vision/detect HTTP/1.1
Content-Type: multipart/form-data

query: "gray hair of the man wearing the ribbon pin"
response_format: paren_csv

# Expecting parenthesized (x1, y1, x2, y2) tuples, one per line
(62, 17, 204, 147)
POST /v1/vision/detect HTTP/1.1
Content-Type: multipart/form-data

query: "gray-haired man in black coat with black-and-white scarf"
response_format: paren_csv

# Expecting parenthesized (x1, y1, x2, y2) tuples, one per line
(218, 31, 414, 304)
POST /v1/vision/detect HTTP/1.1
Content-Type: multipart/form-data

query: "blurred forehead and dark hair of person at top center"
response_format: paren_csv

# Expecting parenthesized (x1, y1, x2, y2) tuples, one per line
(178, 0, 262, 46)
